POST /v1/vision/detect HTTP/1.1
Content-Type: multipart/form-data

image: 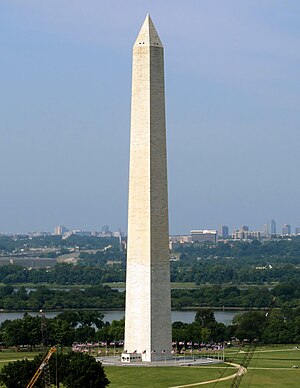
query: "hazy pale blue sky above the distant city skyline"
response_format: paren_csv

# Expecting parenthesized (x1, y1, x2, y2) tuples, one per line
(0, 0, 300, 233)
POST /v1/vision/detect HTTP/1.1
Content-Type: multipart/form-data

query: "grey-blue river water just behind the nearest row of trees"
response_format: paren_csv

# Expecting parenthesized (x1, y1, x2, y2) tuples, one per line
(0, 310, 245, 325)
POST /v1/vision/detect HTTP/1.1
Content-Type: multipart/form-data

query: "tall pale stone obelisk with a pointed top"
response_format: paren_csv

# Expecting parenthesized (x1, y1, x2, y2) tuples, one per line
(124, 15, 172, 361)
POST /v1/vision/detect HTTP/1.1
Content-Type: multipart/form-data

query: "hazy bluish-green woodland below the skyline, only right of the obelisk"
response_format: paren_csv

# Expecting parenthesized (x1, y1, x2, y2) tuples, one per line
(171, 237, 300, 284)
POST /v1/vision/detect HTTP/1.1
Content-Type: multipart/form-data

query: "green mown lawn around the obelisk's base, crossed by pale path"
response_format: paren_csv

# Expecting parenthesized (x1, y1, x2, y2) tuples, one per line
(0, 345, 300, 388)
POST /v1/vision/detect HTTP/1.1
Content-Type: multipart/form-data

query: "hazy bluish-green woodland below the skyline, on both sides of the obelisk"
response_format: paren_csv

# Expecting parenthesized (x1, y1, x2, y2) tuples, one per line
(0, 236, 300, 285)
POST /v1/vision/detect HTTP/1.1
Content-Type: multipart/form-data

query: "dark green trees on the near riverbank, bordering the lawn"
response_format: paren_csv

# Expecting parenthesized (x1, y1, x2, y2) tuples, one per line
(0, 306, 300, 350)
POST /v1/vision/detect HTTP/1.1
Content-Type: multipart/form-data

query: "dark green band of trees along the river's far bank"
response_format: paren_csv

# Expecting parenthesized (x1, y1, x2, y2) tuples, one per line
(0, 282, 300, 311)
